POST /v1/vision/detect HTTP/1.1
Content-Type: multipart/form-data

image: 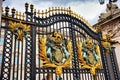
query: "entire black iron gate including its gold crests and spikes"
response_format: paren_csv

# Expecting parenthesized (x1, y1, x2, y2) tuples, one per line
(0, 3, 119, 80)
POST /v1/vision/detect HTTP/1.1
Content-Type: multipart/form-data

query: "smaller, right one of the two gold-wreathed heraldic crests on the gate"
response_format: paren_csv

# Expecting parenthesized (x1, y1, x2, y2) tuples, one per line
(77, 38, 101, 75)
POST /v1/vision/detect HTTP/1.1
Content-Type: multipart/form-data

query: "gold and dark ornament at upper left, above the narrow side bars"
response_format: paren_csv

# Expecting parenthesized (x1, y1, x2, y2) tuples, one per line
(8, 21, 30, 41)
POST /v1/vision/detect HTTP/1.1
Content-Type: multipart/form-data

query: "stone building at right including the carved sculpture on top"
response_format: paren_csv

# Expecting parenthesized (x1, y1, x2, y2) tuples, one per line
(94, 3, 120, 70)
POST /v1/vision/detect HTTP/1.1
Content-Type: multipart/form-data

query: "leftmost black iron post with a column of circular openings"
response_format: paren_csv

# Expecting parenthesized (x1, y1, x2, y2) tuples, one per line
(0, 20, 13, 80)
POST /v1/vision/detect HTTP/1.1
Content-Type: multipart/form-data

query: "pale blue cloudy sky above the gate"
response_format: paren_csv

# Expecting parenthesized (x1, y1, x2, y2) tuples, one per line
(3, 0, 120, 25)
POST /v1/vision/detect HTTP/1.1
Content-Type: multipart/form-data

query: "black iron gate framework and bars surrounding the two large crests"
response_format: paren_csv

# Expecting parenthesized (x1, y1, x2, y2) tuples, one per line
(0, 3, 119, 80)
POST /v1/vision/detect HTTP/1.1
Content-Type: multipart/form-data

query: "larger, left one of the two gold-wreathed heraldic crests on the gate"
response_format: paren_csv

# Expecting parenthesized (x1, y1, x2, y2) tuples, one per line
(39, 31, 72, 76)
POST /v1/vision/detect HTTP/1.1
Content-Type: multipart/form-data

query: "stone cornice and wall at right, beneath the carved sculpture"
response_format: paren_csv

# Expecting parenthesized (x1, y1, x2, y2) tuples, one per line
(97, 18, 120, 70)
